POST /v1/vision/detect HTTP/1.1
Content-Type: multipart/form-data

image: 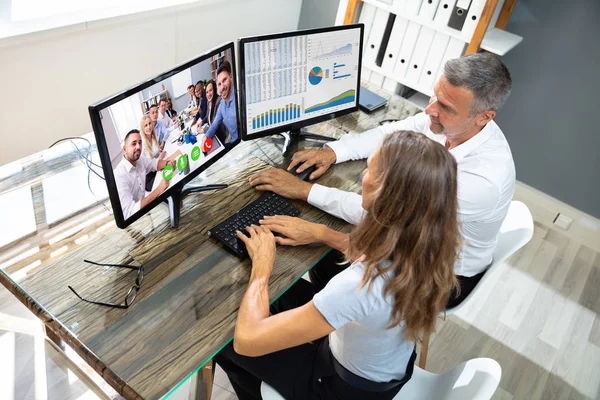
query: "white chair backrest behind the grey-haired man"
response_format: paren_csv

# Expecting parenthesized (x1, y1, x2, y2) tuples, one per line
(446, 201, 533, 315)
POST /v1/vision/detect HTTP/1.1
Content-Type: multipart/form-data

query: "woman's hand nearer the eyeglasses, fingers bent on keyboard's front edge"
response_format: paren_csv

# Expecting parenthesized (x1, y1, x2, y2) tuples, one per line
(237, 225, 276, 276)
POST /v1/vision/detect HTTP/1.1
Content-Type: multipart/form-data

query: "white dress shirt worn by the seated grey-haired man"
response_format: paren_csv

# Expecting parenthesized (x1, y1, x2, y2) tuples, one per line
(308, 113, 515, 277)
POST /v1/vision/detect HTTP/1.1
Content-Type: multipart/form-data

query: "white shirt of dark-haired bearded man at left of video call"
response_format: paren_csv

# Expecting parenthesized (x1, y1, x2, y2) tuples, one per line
(115, 152, 158, 219)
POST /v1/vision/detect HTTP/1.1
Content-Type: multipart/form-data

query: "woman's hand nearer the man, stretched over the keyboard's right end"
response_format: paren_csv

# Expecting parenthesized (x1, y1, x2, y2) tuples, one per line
(259, 215, 324, 246)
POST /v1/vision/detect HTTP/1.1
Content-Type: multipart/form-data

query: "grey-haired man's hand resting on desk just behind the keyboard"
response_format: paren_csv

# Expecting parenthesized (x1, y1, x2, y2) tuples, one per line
(250, 168, 313, 201)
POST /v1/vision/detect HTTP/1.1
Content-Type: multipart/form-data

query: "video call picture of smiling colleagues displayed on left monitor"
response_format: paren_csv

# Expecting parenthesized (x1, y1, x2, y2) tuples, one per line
(95, 49, 238, 219)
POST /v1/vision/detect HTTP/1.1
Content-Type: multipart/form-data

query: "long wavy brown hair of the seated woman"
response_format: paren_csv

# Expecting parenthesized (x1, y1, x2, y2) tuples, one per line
(347, 131, 460, 341)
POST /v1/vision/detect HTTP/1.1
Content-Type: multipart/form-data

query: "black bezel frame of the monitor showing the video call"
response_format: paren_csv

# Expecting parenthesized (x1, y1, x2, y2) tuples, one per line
(88, 42, 242, 229)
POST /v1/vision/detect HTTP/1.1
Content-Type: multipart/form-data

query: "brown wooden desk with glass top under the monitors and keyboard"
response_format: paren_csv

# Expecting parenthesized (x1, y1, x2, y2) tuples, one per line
(0, 86, 418, 398)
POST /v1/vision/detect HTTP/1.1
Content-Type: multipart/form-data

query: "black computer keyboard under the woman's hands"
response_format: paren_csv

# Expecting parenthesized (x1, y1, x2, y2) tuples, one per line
(208, 192, 300, 259)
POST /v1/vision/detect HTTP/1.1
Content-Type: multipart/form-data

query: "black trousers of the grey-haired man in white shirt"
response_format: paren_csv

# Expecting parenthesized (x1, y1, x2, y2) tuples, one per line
(308, 250, 485, 308)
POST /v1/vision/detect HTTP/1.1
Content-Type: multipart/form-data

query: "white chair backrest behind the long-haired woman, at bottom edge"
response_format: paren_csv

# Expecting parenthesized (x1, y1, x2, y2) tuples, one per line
(394, 358, 502, 400)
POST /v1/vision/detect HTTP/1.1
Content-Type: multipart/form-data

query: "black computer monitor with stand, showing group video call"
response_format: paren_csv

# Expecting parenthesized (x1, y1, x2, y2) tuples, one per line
(89, 42, 240, 228)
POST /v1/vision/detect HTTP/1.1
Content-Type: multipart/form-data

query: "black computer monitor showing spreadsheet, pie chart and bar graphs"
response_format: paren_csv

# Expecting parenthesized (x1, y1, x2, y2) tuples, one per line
(239, 24, 364, 152)
